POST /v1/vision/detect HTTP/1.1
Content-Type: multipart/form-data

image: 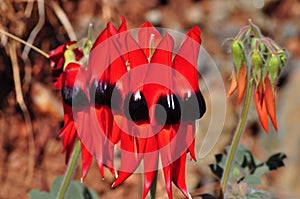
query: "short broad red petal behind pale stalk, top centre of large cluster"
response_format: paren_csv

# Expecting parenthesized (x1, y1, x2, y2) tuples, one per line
(138, 22, 162, 58)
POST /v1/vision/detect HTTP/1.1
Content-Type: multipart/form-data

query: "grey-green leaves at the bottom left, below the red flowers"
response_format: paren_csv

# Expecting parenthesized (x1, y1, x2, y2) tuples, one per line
(29, 176, 99, 199)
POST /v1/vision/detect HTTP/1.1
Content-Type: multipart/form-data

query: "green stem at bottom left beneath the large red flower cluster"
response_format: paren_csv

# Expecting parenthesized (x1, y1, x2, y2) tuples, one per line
(56, 140, 81, 199)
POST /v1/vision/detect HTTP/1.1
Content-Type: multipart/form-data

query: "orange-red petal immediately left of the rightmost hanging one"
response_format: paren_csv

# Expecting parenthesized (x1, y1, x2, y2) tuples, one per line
(254, 90, 269, 133)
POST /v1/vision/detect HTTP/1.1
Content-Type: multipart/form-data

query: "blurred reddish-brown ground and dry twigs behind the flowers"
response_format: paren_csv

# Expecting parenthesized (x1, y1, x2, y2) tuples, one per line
(0, 0, 300, 199)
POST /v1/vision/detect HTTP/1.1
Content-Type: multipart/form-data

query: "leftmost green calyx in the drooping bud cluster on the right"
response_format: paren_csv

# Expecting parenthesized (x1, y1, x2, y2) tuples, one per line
(231, 40, 246, 72)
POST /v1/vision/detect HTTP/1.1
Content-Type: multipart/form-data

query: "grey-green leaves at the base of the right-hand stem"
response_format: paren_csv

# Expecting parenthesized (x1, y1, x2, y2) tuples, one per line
(209, 145, 286, 199)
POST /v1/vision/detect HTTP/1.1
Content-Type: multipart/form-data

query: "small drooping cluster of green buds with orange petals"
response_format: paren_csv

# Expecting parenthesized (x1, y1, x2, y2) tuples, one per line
(228, 21, 287, 133)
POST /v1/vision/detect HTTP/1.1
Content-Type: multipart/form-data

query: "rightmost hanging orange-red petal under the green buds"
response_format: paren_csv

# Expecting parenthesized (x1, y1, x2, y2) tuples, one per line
(264, 77, 278, 131)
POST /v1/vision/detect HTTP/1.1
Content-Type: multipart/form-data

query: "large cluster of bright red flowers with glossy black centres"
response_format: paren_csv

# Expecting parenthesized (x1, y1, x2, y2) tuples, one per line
(50, 18, 206, 198)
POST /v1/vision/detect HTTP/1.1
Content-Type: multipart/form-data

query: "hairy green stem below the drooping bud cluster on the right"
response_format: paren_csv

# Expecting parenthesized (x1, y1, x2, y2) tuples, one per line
(221, 80, 253, 195)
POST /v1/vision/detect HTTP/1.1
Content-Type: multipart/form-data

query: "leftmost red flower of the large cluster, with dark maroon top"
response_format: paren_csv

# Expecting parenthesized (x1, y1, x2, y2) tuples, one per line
(49, 42, 93, 179)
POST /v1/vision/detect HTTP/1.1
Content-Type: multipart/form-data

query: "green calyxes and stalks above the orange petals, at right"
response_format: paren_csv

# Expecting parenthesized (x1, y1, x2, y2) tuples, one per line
(231, 21, 288, 90)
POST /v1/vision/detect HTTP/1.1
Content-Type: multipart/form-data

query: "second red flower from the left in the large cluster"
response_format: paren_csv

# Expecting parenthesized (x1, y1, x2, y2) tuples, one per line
(83, 18, 127, 177)
